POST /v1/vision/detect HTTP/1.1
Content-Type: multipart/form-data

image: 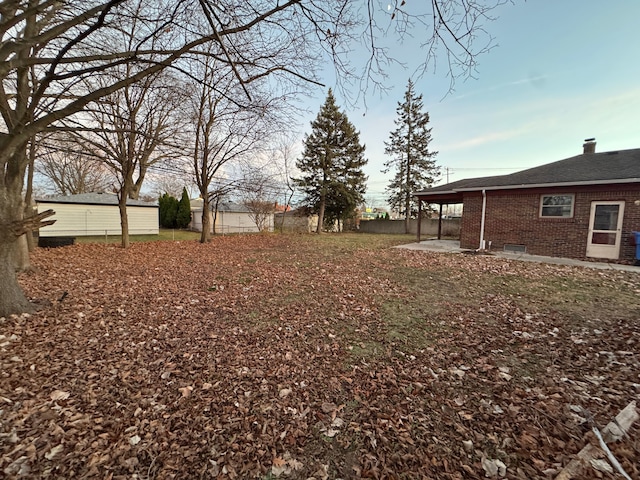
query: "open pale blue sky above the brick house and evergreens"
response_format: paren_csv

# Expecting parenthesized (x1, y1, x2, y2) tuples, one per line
(300, 0, 640, 207)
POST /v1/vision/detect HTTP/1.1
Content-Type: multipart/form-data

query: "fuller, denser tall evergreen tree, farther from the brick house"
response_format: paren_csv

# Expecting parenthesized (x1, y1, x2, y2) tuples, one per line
(294, 89, 367, 233)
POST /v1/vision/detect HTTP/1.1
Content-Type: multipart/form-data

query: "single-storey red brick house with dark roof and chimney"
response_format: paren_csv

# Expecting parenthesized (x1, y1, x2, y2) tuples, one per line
(415, 139, 640, 263)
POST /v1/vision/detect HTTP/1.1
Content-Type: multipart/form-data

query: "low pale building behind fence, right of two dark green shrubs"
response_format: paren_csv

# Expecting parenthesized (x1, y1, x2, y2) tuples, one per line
(190, 199, 273, 234)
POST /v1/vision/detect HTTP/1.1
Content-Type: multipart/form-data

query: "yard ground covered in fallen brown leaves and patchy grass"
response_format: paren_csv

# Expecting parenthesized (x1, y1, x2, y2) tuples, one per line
(0, 235, 640, 480)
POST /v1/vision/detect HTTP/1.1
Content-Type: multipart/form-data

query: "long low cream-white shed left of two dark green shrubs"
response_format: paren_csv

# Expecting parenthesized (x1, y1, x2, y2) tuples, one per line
(36, 193, 159, 237)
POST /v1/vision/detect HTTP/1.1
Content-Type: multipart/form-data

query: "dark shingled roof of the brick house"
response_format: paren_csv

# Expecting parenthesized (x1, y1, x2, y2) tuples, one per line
(415, 148, 640, 196)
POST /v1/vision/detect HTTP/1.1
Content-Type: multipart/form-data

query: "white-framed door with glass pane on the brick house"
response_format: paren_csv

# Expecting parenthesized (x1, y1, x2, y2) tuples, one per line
(587, 202, 624, 259)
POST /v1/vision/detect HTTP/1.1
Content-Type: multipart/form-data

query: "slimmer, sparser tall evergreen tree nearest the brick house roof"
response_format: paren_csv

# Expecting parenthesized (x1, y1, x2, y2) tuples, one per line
(383, 80, 439, 233)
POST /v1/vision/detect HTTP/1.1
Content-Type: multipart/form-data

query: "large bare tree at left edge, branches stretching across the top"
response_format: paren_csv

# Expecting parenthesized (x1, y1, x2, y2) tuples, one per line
(0, 0, 510, 315)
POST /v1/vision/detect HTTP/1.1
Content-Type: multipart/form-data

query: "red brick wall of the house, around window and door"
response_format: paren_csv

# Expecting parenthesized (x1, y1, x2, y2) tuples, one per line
(460, 184, 640, 261)
